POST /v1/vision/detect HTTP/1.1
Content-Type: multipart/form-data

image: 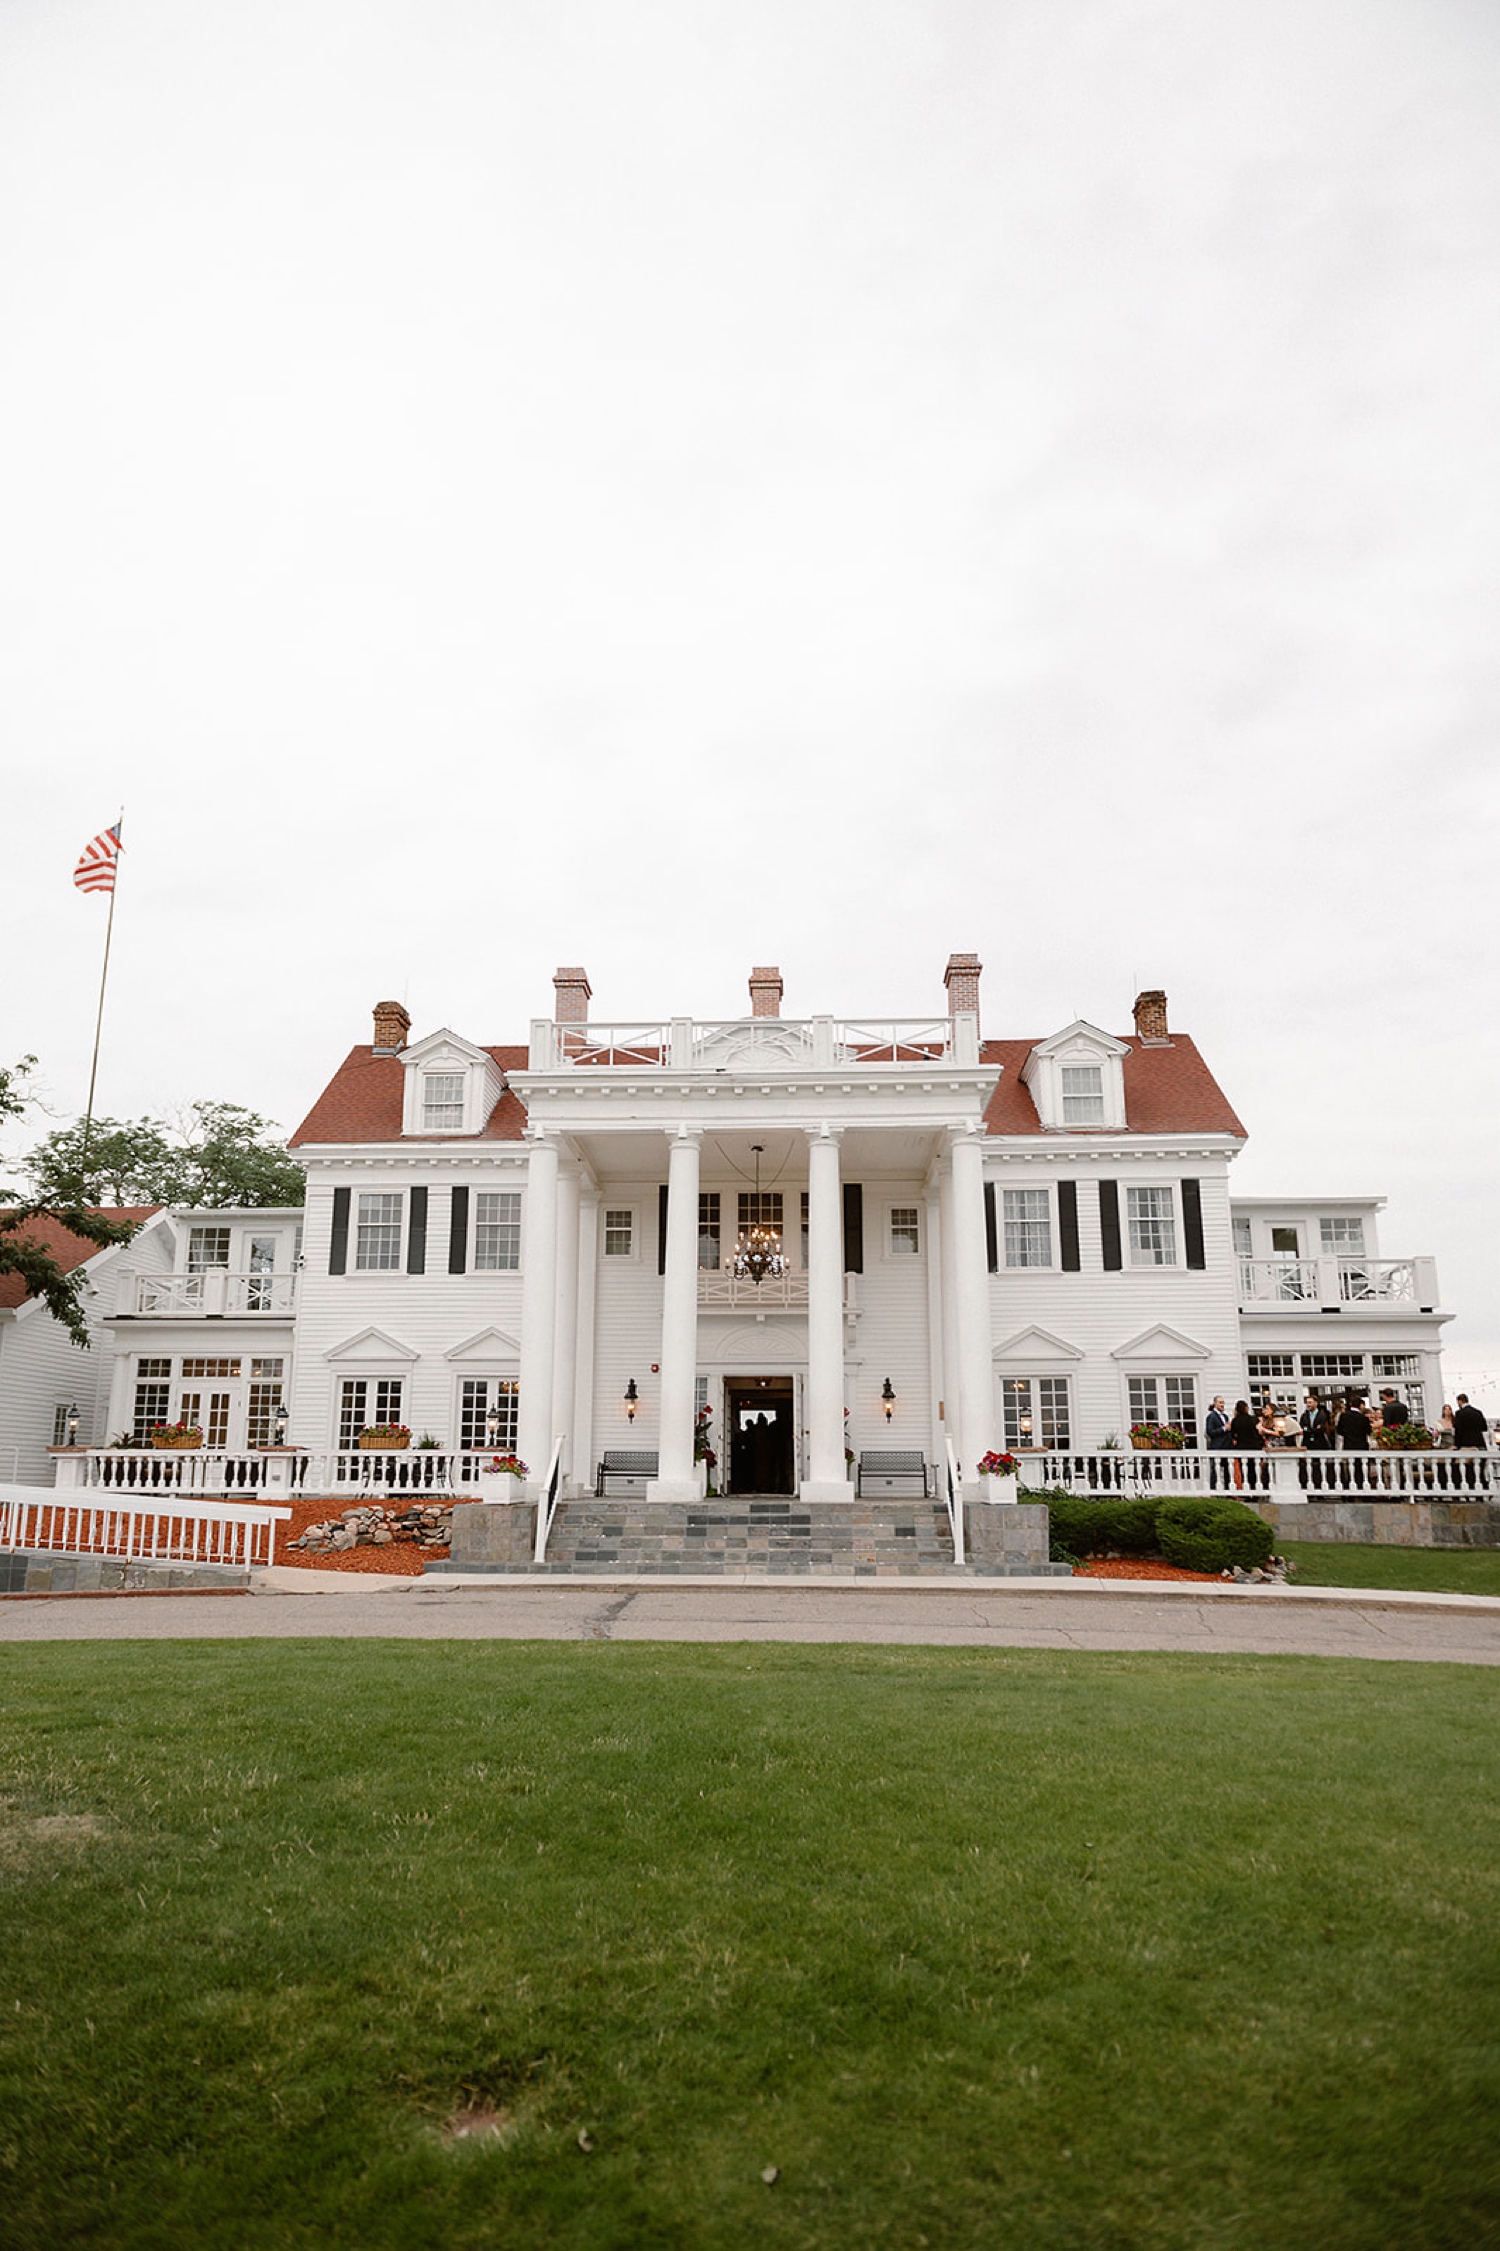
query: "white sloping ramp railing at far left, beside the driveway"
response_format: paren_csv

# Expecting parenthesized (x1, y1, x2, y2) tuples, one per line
(0, 1486, 291, 1567)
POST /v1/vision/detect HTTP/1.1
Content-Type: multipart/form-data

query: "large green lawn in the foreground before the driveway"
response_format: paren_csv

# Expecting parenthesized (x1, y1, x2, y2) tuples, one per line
(0, 1641, 1500, 2251)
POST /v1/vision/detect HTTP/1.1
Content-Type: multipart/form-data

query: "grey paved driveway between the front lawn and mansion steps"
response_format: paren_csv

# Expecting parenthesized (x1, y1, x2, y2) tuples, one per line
(0, 1569, 1500, 1666)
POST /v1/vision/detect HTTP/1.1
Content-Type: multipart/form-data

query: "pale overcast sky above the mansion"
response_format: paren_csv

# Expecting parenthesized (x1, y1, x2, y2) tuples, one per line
(0, 0, 1500, 1411)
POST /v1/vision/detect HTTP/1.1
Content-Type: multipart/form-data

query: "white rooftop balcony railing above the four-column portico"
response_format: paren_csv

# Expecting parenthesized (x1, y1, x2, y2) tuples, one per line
(529, 1015, 980, 1071)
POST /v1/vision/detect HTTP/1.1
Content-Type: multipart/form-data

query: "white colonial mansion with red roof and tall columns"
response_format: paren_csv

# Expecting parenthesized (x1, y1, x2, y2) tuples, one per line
(20, 954, 1448, 1501)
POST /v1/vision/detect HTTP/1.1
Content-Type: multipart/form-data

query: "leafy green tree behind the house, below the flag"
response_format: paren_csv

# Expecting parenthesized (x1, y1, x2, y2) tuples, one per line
(27, 1103, 306, 1209)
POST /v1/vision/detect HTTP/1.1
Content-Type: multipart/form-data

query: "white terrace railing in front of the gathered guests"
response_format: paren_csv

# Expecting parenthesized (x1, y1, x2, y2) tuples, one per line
(1020, 1447, 1500, 1501)
